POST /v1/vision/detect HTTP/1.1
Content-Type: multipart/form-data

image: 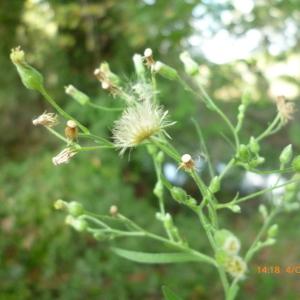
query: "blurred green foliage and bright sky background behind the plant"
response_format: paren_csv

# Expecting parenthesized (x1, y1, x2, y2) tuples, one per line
(0, 0, 300, 300)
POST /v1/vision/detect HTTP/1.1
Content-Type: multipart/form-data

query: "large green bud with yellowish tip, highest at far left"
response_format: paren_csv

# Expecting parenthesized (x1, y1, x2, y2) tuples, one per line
(10, 47, 44, 92)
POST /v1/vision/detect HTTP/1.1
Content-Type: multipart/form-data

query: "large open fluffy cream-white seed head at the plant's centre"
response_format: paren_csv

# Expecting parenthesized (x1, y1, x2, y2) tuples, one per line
(113, 101, 175, 154)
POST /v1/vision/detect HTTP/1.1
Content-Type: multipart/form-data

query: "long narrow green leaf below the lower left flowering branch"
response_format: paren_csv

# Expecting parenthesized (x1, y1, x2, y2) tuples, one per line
(112, 248, 199, 264)
